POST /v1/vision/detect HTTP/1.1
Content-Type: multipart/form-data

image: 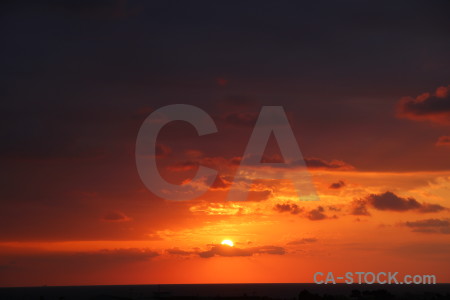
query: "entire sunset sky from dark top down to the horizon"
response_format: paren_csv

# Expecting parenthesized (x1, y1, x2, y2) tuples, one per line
(0, 0, 450, 286)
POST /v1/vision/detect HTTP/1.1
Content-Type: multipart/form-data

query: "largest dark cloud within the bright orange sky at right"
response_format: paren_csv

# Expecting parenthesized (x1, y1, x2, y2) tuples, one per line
(351, 191, 447, 216)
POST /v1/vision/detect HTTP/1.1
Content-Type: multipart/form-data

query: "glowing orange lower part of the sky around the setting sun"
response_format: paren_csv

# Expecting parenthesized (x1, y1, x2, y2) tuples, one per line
(0, 161, 450, 285)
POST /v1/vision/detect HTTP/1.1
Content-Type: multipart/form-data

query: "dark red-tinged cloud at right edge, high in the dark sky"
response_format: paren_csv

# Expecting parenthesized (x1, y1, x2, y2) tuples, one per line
(397, 85, 450, 125)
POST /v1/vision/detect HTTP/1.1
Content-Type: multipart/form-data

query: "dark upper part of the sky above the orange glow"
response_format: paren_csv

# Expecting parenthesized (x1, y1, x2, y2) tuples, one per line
(0, 1, 450, 178)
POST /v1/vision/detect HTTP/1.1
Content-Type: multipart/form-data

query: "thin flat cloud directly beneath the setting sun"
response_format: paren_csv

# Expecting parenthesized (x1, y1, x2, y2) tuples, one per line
(198, 245, 286, 258)
